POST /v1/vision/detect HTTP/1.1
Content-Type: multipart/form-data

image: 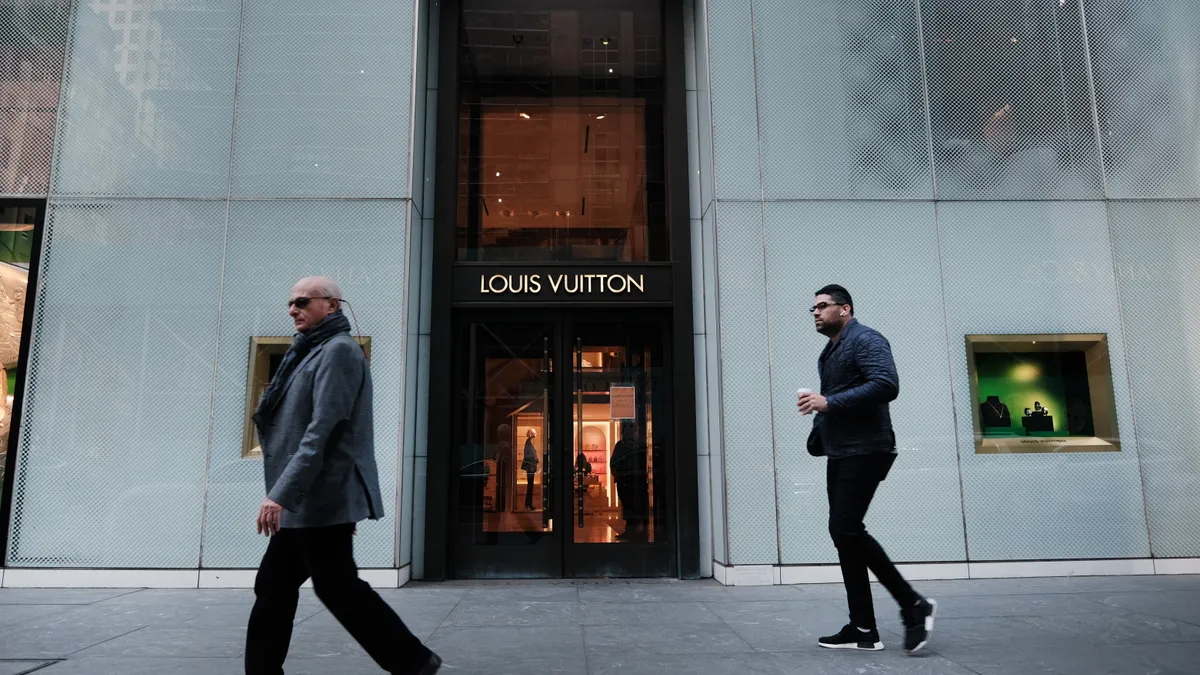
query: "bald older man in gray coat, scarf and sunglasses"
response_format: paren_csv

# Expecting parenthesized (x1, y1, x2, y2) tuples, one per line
(246, 277, 442, 675)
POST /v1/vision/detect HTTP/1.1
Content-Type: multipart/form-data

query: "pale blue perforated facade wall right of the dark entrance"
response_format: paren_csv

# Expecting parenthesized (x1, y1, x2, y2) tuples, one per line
(689, 0, 1200, 565)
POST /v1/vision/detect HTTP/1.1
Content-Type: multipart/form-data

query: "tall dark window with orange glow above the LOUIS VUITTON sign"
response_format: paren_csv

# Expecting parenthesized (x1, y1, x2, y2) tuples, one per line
(457, 0, 668, 262)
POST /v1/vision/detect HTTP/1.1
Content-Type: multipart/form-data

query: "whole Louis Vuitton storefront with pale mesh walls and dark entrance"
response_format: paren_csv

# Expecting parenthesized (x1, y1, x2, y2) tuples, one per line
(0, 0, 1200, 586)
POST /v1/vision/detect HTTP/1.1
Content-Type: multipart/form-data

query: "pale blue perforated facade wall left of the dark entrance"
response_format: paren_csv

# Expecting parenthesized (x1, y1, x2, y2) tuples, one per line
(7, 0, 420, 568)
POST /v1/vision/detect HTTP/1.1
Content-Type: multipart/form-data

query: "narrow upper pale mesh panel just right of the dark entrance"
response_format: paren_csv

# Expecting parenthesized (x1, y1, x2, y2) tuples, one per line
(708, 0, 762, 199)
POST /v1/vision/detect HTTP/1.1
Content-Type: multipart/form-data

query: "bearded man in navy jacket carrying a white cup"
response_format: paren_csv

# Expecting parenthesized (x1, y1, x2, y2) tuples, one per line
(797, 286, 936, 653)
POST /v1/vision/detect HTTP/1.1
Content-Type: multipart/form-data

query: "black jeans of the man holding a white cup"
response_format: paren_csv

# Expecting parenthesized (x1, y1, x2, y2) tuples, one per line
(826, 453, 920, 628)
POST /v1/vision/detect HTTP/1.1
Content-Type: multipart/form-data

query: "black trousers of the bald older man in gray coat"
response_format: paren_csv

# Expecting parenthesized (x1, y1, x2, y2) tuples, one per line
(246, 524, 431, 675)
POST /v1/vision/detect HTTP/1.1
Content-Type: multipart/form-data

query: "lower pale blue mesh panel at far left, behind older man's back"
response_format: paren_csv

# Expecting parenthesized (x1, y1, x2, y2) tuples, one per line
(8, 201, 224, 567)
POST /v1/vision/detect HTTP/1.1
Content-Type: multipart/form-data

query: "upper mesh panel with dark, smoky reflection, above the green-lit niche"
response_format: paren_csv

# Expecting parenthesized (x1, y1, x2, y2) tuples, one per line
(920, 0, 1100, 199)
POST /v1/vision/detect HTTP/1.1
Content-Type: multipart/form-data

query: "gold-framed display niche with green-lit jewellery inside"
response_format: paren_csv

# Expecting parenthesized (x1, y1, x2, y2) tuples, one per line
(966, 334, 1121, 454)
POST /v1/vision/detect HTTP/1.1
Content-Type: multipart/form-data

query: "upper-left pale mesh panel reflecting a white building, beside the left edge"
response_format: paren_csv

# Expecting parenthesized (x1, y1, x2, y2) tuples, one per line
(53, 0, 241, 197)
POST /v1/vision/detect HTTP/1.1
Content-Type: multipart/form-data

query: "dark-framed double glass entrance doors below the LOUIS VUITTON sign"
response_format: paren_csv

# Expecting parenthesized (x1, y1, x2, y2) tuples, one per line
(446, 312, 676, 578)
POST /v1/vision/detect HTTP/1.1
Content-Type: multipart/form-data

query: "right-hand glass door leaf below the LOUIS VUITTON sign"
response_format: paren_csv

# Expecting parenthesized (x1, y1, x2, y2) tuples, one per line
(565, 315, 676, 577)
